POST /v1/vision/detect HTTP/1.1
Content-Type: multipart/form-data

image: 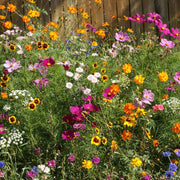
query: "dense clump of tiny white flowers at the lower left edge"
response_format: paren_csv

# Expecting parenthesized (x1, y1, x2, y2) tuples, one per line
(0, 128, 25, 149)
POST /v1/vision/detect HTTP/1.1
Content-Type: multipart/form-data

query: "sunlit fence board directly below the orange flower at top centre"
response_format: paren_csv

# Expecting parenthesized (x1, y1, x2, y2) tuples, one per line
(91, 0, 104, 28)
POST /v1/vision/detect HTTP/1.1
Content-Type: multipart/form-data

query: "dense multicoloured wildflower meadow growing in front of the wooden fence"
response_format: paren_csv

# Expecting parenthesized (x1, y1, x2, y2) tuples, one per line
(0, 0, 180, 180)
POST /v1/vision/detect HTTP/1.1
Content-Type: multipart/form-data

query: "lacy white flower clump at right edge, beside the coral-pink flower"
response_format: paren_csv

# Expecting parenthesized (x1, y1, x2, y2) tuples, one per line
(163, 97, 180, 113)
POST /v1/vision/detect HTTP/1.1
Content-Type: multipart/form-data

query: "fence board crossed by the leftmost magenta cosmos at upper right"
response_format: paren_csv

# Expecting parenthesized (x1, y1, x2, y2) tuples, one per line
(130, 0, 143, 33)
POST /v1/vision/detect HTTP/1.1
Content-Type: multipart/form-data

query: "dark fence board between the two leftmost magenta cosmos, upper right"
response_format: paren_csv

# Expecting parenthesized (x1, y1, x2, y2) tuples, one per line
(142, 0, 155, 31)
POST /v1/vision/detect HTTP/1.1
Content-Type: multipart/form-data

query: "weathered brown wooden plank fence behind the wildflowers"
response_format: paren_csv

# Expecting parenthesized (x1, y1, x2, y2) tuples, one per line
(0, 0, 180, 32)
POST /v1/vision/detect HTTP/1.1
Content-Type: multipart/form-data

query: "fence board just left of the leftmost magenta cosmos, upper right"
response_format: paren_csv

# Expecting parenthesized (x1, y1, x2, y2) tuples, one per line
(117, 0, 131, 29)
